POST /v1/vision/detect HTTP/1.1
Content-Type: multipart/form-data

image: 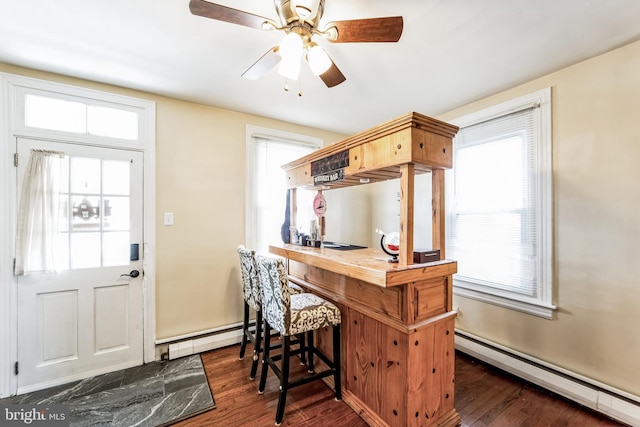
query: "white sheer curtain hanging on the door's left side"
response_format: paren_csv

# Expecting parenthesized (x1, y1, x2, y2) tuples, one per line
(15, 150, 64, 276)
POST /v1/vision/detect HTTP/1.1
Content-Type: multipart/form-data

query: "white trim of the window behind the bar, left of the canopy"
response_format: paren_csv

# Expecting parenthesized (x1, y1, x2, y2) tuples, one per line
(245, 125, 324, 248)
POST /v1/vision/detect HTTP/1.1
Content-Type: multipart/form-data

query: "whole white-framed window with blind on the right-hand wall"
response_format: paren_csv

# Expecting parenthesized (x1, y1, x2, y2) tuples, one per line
(446, 90, 554, 317)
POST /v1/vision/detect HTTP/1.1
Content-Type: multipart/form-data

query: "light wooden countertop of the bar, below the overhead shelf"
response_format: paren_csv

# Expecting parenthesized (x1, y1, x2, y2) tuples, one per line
(269, 244, 458, 288)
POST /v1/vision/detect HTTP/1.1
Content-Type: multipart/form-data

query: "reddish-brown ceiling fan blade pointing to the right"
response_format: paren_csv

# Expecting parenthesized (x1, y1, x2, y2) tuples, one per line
(325, 16, 404, 43)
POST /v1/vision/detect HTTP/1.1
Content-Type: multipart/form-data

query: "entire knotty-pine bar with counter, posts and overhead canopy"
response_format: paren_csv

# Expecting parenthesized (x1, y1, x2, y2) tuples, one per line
(270, 113, 460, 427)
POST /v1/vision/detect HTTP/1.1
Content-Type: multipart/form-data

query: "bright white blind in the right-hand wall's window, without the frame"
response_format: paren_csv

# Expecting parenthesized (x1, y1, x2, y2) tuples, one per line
(448, 109, 536, 296)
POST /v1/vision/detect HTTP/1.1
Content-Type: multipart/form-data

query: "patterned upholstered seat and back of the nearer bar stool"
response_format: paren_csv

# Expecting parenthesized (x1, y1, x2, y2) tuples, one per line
(256, 255, 341, 335)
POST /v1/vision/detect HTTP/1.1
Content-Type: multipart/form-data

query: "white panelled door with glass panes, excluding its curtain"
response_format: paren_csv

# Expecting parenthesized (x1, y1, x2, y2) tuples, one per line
(17, 138, 143, 394)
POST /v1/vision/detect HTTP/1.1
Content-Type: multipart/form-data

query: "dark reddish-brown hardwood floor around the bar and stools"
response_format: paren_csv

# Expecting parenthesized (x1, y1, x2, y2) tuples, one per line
(174, 345, 622, 427)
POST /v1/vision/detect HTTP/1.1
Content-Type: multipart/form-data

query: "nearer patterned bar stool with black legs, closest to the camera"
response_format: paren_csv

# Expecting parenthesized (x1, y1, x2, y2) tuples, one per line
(256, 255, 342, 425)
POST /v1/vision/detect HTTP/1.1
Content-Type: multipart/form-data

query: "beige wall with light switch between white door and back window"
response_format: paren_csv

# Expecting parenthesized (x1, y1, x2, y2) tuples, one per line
(0, 63, 348, 339)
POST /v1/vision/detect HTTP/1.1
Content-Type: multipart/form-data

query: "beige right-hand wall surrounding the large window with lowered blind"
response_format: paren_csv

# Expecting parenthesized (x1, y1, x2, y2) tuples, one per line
(439, 42, 640, 396)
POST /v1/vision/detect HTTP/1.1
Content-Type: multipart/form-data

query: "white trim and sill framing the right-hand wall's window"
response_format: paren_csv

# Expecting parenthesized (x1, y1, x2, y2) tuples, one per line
(445, 87, 557, 319)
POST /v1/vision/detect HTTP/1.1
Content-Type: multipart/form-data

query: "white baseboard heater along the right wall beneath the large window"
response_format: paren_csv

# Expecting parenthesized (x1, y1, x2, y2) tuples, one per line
(455, 330, 640, 426)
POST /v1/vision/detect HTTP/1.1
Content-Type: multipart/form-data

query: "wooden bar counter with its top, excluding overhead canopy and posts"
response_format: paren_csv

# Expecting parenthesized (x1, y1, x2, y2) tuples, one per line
(270, 245, 460, 426)
